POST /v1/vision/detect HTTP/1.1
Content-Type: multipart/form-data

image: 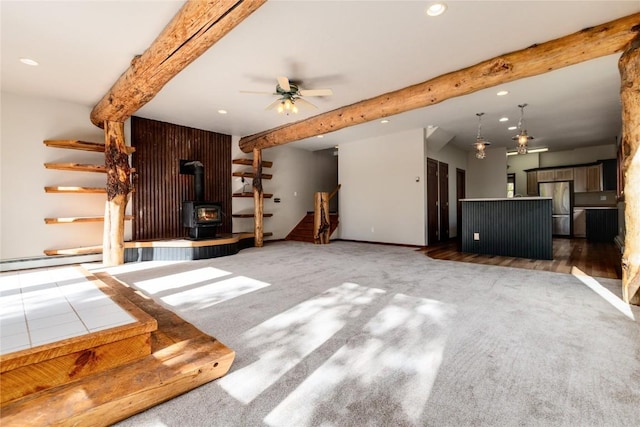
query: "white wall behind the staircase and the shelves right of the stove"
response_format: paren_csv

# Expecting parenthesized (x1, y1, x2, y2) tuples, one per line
(231, 140, 320, 240)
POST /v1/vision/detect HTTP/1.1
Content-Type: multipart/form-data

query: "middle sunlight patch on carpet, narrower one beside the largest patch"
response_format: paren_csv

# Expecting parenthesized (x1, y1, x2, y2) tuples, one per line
(217, 283, 385, 404)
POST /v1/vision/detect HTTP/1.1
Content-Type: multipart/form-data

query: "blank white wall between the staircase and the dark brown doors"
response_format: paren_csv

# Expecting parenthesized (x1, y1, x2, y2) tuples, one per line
(338, 129, 426, 246)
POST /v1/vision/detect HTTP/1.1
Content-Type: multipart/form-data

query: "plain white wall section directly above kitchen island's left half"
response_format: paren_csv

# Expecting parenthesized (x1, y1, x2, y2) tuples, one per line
(467, 148, 507, 199)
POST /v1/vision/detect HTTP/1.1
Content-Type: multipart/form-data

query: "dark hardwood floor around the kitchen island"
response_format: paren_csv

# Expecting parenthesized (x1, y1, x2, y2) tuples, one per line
(421, 238, 622, 279)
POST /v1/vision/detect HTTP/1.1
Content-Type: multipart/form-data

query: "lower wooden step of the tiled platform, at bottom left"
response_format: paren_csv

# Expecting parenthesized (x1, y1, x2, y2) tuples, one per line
(0, 334, 235, 427)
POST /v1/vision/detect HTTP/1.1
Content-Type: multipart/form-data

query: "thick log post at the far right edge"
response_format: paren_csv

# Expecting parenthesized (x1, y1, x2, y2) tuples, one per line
(618, 35, 640, 305)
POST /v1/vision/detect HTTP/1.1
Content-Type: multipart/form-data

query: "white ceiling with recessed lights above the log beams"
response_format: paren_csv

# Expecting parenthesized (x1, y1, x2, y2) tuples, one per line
(0, 0, 640, 154)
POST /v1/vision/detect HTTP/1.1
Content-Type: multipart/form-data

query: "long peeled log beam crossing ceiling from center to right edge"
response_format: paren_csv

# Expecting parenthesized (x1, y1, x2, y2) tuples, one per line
(240, 13, 640, 153)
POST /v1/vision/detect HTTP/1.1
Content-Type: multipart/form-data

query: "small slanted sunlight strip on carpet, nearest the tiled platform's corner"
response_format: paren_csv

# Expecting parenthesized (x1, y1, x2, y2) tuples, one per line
(160, 270, 271, 310)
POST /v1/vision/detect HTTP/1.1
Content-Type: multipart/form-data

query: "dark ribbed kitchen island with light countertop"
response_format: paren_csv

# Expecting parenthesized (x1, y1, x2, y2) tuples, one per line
(461, 197, 553, 260)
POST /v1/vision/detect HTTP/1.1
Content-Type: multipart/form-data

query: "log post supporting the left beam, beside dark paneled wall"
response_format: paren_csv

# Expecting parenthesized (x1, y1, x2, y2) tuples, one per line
(102, 121, 131, 265)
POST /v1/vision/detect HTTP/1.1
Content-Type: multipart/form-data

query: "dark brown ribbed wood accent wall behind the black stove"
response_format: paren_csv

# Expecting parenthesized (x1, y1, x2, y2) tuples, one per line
(131, 117, 232, 240)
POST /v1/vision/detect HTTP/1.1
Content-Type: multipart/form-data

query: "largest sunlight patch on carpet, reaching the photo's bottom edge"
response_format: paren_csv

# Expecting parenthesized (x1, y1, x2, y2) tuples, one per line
(264, 294, 455, 426)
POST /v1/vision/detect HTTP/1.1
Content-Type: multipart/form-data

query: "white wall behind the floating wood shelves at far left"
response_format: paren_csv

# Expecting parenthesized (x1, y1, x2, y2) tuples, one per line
(0, 92, 131, 260)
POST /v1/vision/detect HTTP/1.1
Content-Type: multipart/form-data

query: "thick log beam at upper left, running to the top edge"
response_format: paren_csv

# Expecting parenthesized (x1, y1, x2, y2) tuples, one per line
(91, 0, 266, 127)
